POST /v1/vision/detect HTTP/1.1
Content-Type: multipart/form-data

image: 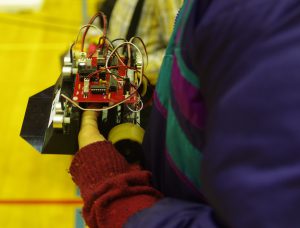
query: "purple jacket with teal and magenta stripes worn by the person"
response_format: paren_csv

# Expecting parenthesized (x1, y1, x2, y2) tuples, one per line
(127, 0, 300, 228)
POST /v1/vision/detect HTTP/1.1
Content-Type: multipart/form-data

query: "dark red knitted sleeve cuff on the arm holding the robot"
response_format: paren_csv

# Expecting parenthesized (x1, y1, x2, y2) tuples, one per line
(70, 141, 162, 228)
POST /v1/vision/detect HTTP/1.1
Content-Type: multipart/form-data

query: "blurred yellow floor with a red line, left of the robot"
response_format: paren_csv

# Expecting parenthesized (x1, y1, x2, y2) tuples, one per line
(0, 0, 99, 228)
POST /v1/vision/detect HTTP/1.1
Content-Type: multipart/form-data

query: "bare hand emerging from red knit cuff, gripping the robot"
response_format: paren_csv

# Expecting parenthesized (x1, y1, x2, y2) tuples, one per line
(78, 111, 106, 149)
